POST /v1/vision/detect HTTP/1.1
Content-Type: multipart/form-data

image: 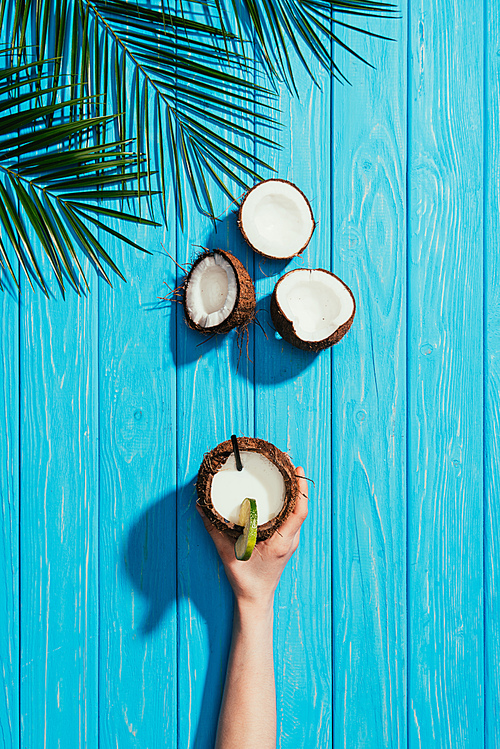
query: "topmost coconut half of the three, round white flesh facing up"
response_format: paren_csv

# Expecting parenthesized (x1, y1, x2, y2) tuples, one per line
(238, 179, 314, 260)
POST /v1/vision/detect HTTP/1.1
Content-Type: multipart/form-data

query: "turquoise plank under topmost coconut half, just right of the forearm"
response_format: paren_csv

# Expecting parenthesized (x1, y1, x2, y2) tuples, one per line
(255, 55, 332, 749)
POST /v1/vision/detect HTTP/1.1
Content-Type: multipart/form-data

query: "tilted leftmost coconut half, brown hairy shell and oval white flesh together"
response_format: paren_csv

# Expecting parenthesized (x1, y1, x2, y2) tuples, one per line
(183, 250, 255, 333)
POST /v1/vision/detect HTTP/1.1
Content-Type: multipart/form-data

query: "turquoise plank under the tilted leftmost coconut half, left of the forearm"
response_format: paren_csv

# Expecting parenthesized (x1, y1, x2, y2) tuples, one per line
(176, 5, 254, 749)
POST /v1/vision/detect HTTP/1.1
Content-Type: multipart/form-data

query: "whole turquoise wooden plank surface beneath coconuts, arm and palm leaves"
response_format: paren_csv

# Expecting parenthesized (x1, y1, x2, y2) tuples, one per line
(0, 0, 500, 749)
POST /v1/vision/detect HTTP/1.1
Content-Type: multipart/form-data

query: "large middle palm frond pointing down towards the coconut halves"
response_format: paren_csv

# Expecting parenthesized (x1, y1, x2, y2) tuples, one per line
(5, 0, 275, 224)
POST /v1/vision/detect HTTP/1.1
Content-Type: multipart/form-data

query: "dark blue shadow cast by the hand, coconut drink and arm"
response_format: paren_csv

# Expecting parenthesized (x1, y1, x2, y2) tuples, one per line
(122, 481, 232, 749)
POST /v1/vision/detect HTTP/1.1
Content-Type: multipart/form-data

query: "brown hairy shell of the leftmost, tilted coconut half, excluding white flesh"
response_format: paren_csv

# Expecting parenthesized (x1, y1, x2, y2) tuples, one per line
(182, 249, 256, 334)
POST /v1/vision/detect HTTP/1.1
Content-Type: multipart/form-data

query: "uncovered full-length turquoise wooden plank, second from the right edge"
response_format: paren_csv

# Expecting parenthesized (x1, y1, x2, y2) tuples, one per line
(408, 0, 484, 749)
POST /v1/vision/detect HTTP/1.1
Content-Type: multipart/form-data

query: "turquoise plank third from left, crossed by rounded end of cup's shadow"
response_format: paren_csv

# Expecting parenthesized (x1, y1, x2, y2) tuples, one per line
(99, 95, 177, 749)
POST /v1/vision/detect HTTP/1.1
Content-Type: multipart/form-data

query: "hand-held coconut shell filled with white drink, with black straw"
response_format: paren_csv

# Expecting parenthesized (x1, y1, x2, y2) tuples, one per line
(196, 437, 299, 541)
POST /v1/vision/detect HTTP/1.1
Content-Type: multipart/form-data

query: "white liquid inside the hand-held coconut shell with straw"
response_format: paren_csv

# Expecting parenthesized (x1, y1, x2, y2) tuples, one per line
(210, 450, 285, 525)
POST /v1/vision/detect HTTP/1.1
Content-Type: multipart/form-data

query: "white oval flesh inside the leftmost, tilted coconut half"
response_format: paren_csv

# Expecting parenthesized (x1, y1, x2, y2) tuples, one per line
(186, 252, 238, 328)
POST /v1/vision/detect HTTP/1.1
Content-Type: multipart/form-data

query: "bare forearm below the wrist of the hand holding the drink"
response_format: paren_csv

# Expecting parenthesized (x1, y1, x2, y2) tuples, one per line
(215, 600, 276, 749)
